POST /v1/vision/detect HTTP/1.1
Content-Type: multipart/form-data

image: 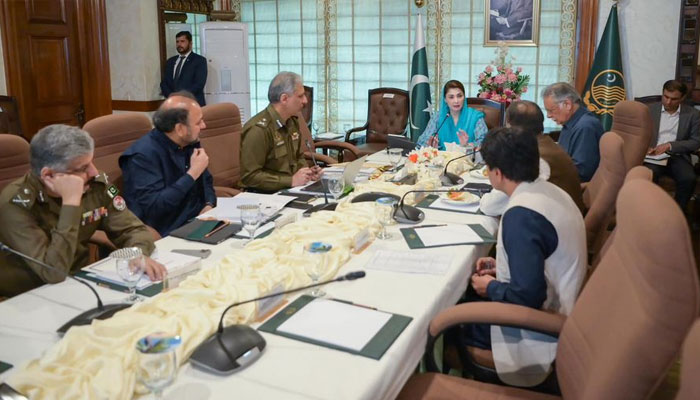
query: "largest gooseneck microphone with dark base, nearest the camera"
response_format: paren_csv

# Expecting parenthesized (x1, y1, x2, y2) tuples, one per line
(190, 271, 365, 375)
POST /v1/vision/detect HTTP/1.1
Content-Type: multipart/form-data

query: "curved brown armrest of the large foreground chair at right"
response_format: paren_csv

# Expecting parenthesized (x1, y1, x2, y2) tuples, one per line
(428, 302, 566, 337)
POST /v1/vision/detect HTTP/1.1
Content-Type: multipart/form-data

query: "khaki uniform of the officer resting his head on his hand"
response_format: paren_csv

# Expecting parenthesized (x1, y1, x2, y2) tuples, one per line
(0, 172, 155, 296)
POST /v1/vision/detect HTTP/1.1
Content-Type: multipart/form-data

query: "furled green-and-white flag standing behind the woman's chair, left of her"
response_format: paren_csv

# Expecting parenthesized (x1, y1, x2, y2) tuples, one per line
(409, 14, 433, 142)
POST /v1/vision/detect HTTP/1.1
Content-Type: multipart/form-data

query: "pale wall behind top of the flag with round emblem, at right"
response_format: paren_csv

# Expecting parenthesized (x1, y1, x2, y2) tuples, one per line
(598, 0, 681, 99)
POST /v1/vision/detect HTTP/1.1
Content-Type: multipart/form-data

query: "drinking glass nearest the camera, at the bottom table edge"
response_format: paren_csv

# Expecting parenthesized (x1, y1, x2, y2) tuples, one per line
(136, 334, 180, 399)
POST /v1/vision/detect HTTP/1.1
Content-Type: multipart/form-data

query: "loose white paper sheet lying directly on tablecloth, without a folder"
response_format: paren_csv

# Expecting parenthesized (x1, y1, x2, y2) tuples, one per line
(365, 250, 452, 275)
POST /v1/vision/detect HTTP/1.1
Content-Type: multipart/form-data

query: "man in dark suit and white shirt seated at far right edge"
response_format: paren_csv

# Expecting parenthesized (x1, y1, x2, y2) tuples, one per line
(644, 80, 700, 212)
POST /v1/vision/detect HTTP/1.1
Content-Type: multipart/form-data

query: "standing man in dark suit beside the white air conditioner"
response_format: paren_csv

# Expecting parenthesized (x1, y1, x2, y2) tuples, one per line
(160, 31, 207, 106)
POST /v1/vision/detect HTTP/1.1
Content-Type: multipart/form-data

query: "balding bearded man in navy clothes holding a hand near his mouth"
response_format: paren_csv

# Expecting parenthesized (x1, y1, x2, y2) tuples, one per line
(119, 92, 216, 236)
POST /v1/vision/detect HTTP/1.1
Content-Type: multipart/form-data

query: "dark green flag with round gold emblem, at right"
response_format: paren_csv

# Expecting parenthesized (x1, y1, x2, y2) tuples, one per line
(583, 4, 626, 131)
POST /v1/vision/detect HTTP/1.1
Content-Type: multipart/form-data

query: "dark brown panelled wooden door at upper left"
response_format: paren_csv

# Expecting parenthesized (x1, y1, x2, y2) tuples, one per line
(2, 0, 111, 138)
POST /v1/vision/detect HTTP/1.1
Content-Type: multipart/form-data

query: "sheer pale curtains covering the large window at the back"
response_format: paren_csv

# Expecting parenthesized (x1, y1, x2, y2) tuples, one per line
(241, 0, 575, 131)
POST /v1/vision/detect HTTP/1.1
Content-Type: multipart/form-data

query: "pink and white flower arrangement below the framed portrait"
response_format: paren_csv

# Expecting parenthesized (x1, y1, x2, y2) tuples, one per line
(478, 42, 530, 105)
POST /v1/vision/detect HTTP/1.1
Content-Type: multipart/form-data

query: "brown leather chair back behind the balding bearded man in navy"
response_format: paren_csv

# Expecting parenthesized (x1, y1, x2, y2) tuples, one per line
(83, 113, 152, 190)
